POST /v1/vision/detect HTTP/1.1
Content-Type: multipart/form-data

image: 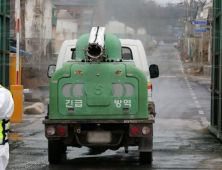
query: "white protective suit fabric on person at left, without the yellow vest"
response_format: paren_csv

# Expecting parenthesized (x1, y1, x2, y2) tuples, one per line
(0, 88, 14, 170)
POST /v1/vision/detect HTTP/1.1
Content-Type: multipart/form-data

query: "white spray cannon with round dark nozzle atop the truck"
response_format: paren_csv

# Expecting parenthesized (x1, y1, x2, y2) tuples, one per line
(83, 27, 107, 61)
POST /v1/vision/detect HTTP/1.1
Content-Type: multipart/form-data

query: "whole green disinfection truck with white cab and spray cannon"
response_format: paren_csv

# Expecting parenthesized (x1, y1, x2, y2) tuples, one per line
(43, 27, 159, 164)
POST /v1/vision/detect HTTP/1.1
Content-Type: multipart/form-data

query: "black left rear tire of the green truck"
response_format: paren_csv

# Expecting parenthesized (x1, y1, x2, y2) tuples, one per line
(48, 140, 62, 164)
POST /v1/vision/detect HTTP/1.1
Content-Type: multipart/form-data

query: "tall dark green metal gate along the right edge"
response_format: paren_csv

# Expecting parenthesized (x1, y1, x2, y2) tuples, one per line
(210, 0, 222, 140)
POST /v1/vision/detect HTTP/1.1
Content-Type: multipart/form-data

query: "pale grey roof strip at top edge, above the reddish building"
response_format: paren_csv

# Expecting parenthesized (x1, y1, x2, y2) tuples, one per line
(52, 0, 99, 6)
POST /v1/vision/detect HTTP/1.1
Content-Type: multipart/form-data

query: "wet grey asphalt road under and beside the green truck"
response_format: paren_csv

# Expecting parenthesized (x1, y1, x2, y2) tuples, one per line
(7, 45, 222, 170)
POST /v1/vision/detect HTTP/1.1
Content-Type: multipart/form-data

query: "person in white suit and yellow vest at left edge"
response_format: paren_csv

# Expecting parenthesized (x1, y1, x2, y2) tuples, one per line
(0, 85, 14, 170)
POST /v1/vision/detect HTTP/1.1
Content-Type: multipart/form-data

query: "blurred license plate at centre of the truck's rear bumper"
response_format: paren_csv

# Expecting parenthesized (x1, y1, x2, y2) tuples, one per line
(87, 131, 112, 143)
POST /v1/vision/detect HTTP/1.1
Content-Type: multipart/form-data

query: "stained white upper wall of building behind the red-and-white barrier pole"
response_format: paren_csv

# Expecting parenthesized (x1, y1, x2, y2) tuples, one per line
(23, 0, 52, 60)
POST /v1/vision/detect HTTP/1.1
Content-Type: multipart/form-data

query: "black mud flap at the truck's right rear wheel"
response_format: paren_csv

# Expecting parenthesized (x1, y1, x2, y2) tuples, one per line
(139, 136, 153, 152)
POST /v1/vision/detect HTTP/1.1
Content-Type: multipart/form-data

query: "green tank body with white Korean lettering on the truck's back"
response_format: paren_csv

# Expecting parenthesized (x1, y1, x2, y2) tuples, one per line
(49, 34, 148, 120)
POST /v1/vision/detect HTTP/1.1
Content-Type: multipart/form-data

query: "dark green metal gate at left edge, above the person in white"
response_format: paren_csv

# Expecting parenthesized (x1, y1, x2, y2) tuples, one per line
(0, 0, 10, 87)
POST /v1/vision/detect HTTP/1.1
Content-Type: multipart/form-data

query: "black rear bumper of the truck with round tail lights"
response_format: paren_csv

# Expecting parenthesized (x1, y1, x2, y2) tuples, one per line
(43, 120, 154, 152)
